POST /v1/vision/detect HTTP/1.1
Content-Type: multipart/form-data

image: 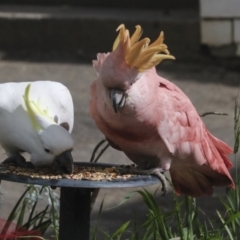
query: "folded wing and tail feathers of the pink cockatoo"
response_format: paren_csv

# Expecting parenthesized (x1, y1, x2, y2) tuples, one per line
(158, 77, 234, 197)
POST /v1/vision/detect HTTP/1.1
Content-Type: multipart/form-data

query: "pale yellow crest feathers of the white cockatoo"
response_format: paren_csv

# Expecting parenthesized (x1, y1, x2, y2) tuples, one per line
(23, 84, 56, 131)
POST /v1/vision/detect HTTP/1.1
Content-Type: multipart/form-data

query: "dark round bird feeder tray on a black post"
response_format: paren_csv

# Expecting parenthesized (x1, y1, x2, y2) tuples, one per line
(0, 162, 160, 240)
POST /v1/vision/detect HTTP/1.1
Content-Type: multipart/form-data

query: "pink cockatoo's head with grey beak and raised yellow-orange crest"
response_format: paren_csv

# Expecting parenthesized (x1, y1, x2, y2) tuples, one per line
(93, 24, 175, 112)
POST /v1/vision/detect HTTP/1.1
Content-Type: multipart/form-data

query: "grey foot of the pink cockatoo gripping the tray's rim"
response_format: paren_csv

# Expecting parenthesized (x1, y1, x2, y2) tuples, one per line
(117, 164, 167, 196)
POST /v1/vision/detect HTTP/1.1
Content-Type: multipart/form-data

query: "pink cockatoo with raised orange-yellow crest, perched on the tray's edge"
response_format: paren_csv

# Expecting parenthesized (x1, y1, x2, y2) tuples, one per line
(89, 24, 234, 197)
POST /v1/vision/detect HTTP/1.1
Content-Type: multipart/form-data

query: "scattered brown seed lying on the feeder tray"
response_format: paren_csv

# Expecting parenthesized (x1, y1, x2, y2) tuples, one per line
(0, 164, 136, 181)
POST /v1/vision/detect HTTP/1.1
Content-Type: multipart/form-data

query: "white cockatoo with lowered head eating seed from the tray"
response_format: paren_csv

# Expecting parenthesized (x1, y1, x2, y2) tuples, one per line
(0, 81, 74, 173)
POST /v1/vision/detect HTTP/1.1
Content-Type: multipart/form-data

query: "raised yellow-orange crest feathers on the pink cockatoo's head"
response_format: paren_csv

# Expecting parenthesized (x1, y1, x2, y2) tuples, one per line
(113, 24, 175, 72)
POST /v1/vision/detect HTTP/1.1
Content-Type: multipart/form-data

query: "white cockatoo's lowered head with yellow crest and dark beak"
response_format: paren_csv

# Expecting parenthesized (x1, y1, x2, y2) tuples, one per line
(23, 84, 73, 173)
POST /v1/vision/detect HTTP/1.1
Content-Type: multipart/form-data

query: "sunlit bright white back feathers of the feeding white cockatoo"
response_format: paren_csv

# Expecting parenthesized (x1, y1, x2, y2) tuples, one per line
(0, 81, 74, 133)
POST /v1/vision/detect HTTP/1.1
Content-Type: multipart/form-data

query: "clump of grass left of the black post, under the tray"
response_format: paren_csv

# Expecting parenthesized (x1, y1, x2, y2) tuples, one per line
(0, 185, 59, 240)
